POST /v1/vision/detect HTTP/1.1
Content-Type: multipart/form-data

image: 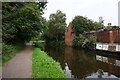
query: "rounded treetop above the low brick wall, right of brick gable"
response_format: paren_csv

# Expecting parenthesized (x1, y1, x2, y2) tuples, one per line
(72, 16, 104, 36)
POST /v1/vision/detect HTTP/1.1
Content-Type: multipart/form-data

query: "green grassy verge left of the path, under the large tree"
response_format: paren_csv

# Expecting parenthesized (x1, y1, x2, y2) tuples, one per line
(2, 44, 24, 65)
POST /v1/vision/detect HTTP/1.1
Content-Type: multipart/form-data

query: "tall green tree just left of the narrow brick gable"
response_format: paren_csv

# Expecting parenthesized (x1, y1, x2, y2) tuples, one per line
(44, 10, 66, 41)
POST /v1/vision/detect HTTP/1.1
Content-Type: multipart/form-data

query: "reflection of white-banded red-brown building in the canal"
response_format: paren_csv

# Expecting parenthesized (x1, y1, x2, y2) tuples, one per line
(96, 55, 120, 77)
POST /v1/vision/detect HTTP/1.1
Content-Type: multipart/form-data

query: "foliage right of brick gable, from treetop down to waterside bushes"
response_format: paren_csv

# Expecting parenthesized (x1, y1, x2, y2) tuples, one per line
(72, 16, 104, 48)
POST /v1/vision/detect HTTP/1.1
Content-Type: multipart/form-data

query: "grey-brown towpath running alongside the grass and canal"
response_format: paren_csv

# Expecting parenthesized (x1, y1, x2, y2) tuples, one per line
(2, 46, 33, 78)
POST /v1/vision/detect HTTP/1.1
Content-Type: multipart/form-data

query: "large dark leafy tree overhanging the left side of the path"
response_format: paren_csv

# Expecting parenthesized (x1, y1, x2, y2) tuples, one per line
(2, 2, 46, 43)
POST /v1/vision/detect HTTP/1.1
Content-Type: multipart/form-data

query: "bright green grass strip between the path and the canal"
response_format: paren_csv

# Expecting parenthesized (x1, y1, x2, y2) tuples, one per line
(32, 48, 65, 78)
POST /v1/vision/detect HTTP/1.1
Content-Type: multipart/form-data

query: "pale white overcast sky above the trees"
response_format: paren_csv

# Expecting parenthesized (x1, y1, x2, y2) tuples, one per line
(43, 0, 120, 26)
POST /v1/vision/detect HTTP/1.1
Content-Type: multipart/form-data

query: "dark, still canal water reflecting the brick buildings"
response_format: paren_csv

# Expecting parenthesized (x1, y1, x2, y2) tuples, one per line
(45, 46, 120, 79)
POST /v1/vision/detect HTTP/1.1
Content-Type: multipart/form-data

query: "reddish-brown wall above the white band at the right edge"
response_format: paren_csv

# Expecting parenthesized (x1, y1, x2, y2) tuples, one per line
(96, 28, 120, 43)
